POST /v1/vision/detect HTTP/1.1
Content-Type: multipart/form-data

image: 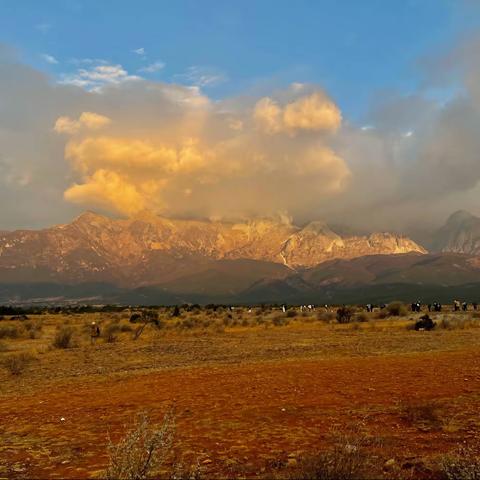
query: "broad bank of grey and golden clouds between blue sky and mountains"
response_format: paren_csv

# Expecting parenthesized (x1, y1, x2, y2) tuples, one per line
(0, 40, 480, 236)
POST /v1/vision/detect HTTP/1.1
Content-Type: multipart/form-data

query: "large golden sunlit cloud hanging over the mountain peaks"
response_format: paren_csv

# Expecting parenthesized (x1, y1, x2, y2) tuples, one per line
(55, 89, 350, 217)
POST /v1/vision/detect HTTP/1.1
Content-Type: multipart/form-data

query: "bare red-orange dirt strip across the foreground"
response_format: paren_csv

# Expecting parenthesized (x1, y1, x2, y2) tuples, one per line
(0, 350, 480, 478)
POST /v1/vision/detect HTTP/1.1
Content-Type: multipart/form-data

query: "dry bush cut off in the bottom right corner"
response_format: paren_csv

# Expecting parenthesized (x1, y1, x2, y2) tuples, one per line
(440, 446, 480, 480)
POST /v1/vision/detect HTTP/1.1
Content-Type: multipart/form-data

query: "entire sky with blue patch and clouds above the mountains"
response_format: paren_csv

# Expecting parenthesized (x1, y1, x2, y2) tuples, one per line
(0, 0, 480, 236)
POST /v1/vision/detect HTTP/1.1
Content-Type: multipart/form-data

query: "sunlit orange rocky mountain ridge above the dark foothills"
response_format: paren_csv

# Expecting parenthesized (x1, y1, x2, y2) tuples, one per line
(0, 211, 426, 286)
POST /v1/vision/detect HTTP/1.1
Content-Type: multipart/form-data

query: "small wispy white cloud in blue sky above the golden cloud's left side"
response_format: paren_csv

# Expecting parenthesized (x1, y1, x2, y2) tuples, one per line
(60, 63, 140, 92)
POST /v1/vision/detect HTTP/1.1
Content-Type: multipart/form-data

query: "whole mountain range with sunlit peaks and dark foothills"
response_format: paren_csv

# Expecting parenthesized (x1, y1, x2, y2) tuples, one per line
(0, 211, 480, 304)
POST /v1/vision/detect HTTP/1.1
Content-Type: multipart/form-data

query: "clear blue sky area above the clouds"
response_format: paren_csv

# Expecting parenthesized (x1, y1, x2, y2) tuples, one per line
(0, 0, 480, 120)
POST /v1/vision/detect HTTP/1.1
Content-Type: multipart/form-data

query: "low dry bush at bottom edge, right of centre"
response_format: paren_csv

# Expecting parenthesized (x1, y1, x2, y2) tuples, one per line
(288, 434, 371, 480)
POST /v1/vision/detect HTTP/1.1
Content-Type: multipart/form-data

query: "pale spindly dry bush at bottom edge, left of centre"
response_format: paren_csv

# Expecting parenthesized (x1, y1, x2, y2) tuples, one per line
(104, 410, 175, 480)
